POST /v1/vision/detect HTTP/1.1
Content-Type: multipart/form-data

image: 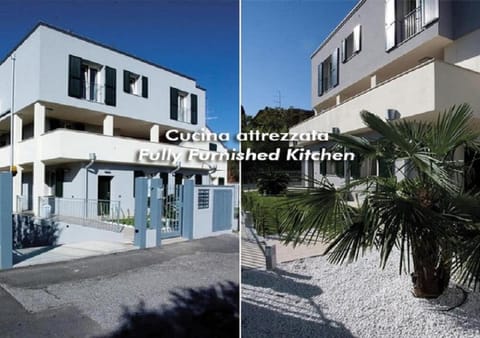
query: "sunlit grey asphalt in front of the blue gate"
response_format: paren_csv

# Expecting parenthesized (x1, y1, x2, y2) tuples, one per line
(0, 235, 239, 338)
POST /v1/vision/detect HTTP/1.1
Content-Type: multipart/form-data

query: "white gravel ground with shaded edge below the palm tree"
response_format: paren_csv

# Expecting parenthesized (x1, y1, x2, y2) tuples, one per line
(242, 253, 480, 338)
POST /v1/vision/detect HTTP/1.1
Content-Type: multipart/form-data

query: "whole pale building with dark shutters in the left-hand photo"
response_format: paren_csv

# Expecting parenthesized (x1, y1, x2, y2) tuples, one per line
(0, 24, 227, 215)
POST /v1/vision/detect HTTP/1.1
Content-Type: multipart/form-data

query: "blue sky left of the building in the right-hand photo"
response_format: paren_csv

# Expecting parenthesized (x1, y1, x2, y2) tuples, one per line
(242, 0, 357, 115)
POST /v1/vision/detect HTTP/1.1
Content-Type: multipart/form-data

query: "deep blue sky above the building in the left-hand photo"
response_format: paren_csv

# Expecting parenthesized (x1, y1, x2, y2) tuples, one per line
(0, 0, 239, 146)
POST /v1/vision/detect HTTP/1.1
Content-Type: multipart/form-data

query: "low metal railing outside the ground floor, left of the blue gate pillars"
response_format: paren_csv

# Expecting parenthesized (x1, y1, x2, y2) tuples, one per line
(38, 196, 120, 224)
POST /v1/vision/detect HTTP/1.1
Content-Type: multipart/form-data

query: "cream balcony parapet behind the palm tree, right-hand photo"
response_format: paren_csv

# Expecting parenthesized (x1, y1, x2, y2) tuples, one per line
(291, 60, 480, 134)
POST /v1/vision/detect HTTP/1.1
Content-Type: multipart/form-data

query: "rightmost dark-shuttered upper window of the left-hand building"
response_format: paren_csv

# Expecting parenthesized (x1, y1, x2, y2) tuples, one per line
(170, 87, 198, 124)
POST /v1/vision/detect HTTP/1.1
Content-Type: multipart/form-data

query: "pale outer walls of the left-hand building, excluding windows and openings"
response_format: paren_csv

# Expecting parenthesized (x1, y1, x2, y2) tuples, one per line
(0, 25, 227, 214)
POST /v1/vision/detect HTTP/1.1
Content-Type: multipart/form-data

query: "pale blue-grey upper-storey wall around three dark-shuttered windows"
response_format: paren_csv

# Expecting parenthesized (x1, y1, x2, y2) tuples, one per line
(37, 26, 205, 131)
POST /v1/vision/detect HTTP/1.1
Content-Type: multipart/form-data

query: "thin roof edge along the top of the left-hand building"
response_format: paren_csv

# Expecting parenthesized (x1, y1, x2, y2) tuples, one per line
(0, 21, 205, 91)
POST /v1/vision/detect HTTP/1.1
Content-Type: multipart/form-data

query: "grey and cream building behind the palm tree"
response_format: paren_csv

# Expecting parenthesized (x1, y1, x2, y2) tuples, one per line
(292, 0, 480, 184)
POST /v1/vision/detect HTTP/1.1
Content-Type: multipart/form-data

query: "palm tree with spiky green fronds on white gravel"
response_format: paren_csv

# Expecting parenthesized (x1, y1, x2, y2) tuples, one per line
(280, 104, 480, 297)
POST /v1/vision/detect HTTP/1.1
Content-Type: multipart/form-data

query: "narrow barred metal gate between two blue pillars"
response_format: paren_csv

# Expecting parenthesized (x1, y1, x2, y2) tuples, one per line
(162, 184, 183, 238)
